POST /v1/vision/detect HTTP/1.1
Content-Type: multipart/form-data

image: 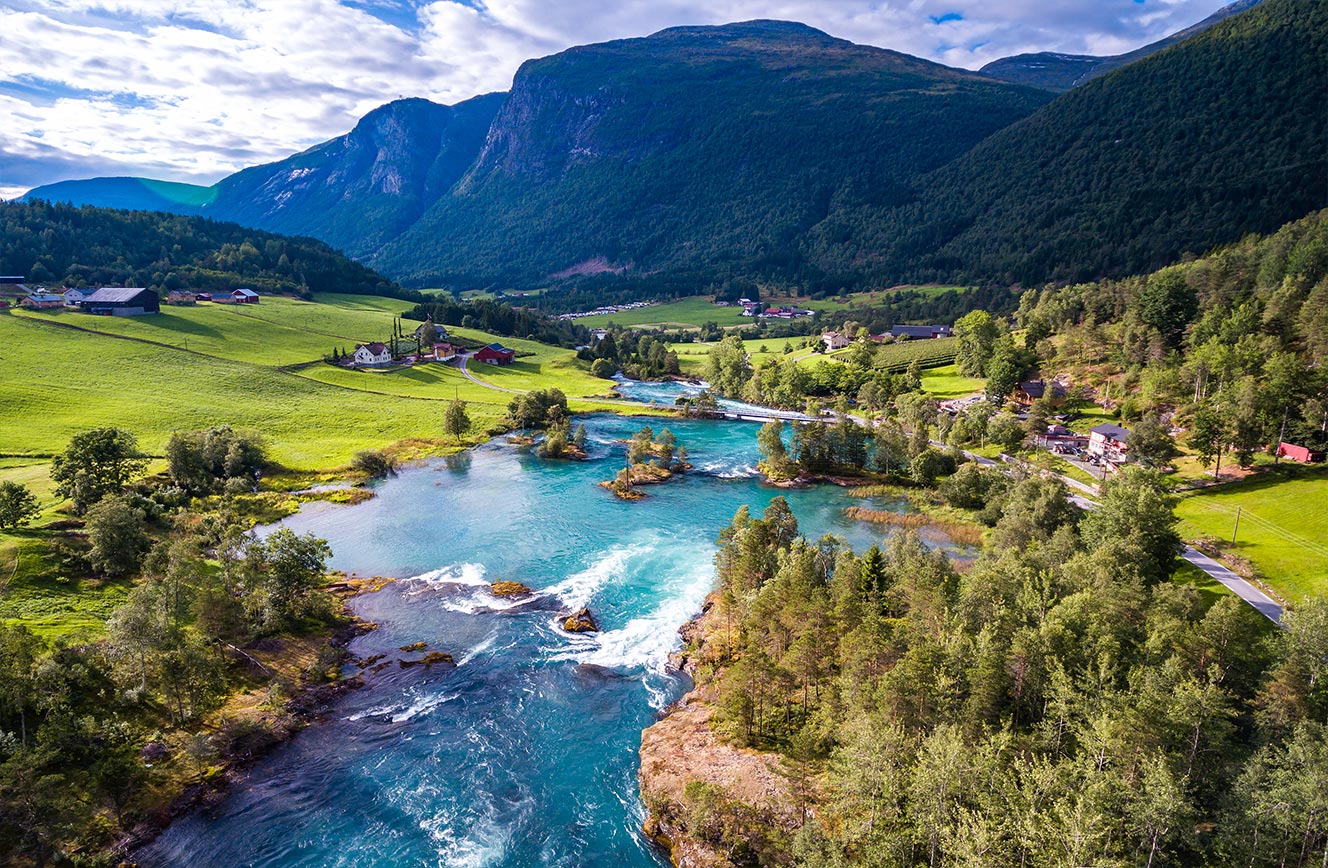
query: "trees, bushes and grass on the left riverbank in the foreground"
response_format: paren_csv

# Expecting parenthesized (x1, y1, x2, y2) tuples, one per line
(0, 427, 352, 865)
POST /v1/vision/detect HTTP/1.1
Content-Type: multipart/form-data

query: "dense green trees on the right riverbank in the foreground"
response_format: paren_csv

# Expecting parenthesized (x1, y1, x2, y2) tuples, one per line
(674, 469, 1328, 868)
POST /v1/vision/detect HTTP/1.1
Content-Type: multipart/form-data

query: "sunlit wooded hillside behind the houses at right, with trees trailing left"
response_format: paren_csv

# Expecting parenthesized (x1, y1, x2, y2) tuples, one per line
(705, 211, 1328, 470)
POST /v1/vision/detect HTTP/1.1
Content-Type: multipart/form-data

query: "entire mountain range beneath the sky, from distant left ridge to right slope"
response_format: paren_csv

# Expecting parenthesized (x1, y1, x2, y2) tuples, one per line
(20, 0, 1328, 300)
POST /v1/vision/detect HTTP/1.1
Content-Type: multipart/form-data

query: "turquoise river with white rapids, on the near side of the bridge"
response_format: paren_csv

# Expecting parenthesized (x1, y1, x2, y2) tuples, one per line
(137, 415, 966, 868)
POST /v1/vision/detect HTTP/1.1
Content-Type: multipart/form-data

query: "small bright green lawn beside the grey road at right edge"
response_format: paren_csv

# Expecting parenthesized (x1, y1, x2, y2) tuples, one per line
(1175, 467, 1328, 601)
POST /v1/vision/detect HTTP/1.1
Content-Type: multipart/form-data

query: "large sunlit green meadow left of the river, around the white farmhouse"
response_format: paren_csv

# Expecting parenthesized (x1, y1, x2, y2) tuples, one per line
(0, 296, 608, 478)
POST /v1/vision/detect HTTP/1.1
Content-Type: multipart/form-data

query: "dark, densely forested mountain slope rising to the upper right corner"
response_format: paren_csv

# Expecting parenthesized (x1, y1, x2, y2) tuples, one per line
(806, 0, 1328, 284)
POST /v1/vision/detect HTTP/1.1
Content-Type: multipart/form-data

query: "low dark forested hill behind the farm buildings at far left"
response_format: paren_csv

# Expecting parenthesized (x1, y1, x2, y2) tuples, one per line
(0, 202, 406, 299)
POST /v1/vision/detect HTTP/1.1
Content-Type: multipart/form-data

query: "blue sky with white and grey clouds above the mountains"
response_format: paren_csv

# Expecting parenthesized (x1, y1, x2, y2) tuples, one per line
(0, 0, 1226, 199)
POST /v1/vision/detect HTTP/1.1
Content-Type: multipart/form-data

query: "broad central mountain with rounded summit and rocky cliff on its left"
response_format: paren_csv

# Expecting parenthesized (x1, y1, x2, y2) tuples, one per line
(369, 21, 1049, 291)
